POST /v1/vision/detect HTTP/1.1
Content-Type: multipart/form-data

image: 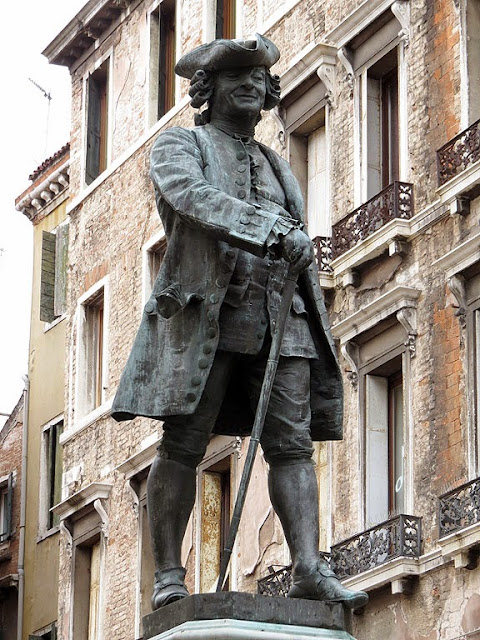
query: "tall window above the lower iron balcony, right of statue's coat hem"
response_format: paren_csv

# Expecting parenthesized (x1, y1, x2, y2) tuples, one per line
(364, 356, 405, 526)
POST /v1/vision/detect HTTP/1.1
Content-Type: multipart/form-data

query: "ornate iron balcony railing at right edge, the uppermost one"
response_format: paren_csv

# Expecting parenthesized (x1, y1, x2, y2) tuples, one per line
(437, 120, 480, 187)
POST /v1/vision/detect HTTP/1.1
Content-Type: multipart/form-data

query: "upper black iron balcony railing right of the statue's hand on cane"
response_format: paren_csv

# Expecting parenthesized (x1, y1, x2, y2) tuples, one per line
(332, 181, 414, 260)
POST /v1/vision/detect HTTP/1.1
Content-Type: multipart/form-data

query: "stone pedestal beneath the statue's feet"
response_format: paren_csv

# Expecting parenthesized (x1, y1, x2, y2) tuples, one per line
(143, 591, 354, 640)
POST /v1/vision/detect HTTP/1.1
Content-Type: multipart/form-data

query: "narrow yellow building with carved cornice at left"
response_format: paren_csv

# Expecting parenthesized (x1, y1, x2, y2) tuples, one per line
(16, 144, 70, 640)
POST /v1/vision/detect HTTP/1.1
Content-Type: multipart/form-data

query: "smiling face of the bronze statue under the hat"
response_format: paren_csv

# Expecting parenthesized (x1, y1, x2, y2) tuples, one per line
(212, 67, 266, 118)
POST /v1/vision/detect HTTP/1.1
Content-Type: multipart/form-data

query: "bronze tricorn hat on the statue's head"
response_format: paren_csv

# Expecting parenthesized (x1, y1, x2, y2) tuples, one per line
(175, 33, 280, 78)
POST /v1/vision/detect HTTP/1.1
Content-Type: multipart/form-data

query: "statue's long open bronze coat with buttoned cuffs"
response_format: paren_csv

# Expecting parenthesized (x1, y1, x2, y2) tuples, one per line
(112, 125, 343, 440)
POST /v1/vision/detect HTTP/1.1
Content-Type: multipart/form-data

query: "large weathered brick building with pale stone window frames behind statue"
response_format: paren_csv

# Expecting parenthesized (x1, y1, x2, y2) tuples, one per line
(31, 0, 480, 640)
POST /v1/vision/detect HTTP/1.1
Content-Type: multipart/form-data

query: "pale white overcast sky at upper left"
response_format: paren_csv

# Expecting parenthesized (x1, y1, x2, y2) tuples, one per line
(0, 0, 85, 426)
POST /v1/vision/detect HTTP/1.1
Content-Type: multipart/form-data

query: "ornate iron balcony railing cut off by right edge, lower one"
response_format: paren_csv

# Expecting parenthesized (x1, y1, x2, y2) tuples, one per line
(438, 478, 480, 538)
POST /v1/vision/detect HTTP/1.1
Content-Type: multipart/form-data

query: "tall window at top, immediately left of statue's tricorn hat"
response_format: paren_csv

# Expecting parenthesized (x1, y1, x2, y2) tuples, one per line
(150, 0, 176, 124)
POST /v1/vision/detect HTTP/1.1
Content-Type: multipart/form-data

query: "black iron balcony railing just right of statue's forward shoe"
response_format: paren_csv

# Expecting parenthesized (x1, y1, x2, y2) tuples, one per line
(331, 514, 422, 580)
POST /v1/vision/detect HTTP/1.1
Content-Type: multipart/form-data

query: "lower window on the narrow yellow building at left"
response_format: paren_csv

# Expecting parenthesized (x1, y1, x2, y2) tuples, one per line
(39, 420, 63, 534)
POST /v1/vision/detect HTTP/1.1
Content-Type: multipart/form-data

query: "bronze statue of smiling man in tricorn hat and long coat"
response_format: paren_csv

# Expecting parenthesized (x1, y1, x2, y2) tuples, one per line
(112, 35, 368, 609)
